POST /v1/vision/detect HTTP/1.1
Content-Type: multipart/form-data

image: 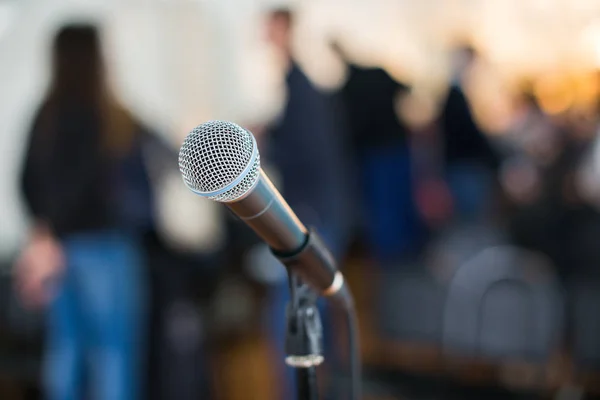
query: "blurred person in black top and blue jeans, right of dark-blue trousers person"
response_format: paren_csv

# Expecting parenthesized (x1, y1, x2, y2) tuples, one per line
(441, 47, 498, 222)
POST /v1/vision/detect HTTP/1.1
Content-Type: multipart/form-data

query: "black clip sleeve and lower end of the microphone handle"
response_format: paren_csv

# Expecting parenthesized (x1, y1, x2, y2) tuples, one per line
(271, 229, 351, 307)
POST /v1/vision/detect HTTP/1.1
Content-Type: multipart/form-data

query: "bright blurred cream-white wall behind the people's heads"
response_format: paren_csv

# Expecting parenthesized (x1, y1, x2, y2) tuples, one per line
(0, 0, 600, 256)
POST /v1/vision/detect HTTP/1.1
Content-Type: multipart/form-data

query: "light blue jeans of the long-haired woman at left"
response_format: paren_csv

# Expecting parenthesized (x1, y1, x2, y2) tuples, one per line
(43, 232, 146, 400)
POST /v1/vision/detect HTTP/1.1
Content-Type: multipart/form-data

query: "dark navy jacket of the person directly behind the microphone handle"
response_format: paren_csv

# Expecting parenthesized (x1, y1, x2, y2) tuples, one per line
(267, 66, 347, 247)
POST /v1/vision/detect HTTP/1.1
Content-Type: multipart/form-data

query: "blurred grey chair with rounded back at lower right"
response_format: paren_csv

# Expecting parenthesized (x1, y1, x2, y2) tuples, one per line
(443, 246, 565, 361)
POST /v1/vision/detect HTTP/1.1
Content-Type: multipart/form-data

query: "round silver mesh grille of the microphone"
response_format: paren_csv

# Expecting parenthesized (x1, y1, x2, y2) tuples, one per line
(179, 121, 260, 202)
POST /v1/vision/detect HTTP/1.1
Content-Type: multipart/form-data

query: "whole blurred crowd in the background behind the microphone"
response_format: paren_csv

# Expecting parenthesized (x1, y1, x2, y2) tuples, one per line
(0, 2, 600, 400)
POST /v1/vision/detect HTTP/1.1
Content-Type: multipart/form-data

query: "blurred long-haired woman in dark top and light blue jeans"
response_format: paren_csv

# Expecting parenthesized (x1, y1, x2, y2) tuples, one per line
(16, 25, 153, 400)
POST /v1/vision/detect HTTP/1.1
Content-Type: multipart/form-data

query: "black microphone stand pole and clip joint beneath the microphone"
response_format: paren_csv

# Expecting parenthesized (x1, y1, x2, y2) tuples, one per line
(285, 272, 324, 400)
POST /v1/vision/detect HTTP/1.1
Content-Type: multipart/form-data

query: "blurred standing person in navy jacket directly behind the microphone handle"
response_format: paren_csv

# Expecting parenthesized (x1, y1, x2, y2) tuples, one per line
(266, 9, 347, 399)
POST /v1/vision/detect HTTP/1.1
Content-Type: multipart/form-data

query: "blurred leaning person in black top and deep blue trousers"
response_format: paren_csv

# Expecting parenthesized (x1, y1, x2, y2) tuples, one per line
(341, 53, 425, 270)
